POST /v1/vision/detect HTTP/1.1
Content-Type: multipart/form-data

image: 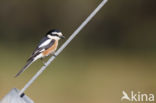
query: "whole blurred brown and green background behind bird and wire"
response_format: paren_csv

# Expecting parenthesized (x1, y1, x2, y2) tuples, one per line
(0, 0, 156, 103)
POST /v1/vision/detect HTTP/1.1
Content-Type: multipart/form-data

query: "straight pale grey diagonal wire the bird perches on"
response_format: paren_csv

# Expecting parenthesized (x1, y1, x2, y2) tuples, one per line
(19, 0, 107, 95)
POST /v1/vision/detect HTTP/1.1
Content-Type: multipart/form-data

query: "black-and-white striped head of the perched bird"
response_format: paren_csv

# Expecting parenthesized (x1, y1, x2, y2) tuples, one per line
(46, 29, 65, 40)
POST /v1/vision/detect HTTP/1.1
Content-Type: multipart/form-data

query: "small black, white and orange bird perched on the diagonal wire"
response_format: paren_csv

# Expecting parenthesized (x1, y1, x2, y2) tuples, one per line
(15, 29, 65, 77)
